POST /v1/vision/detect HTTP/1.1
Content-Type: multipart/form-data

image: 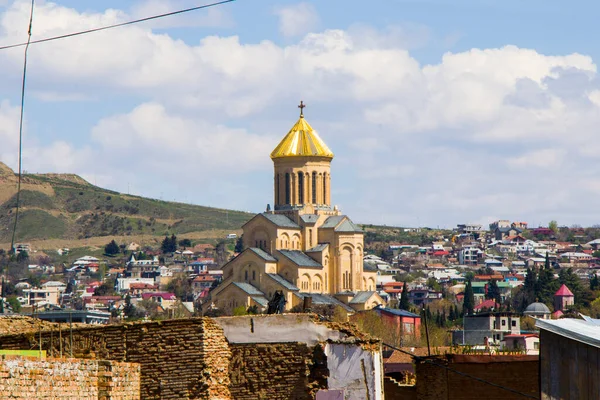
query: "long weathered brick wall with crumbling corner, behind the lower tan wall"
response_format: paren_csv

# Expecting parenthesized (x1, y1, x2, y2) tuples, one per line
(0, 318, 230, 399)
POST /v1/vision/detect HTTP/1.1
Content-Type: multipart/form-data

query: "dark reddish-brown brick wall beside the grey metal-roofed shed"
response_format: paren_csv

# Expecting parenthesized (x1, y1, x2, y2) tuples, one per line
(416, 355, 539, 400)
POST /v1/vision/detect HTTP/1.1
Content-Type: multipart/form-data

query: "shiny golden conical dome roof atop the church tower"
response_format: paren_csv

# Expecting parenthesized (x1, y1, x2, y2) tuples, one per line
(271, 114, 333, 159)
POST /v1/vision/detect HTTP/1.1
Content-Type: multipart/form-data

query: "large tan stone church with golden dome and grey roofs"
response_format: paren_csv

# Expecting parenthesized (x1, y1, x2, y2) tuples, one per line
(207, 102, 384, 313)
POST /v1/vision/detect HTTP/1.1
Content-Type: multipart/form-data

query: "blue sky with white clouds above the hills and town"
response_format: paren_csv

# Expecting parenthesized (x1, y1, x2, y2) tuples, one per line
(0, 0, 600, 227)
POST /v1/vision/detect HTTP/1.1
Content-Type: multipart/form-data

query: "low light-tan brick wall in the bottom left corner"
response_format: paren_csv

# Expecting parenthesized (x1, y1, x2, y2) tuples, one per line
(0, 357, 140, 400)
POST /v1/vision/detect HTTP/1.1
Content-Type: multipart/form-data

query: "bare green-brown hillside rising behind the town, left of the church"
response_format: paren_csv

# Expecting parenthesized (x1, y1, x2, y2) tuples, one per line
(0, 163, 252, 243)
